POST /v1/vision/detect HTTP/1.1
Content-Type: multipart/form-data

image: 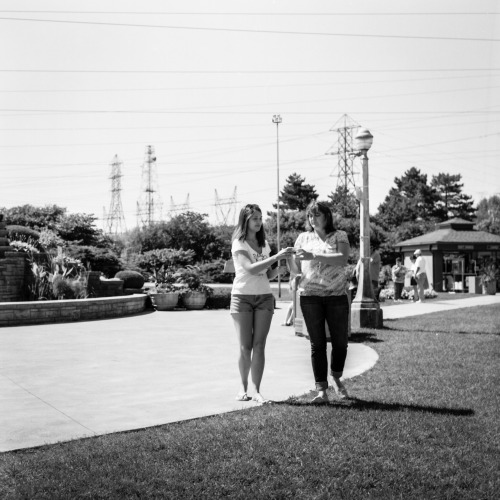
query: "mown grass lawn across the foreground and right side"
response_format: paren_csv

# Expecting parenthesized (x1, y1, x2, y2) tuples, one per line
(0, 306, 500, 500)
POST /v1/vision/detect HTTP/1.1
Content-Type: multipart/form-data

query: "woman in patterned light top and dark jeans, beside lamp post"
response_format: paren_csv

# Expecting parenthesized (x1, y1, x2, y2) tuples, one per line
(288, 201, 350, 403)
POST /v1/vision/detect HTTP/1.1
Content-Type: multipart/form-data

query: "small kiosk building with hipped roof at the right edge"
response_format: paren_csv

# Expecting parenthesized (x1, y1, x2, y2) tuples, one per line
(395, 218, 500, 293)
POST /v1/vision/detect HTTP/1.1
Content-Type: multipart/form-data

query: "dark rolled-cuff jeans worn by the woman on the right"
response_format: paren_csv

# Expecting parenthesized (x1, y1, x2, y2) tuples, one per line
(300, 295, 349, 390)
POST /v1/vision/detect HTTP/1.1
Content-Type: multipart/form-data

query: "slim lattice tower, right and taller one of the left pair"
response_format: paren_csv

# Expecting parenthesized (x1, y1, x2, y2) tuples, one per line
(137, 146, 161, 226)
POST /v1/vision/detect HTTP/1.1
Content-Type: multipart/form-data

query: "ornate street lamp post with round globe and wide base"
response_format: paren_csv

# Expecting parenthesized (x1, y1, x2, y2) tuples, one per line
(351, 129, 383, 328)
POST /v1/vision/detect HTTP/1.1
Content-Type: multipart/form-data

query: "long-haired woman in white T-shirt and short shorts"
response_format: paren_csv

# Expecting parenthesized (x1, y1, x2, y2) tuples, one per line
(230, 204, 294, 403)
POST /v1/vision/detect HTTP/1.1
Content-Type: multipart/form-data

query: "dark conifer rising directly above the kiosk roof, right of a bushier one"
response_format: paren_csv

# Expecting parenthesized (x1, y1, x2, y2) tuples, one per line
(431, 173, 475, 220)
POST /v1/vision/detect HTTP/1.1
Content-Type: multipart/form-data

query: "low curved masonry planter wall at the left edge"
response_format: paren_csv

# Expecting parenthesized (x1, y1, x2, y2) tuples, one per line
(0, 294, 147, 327)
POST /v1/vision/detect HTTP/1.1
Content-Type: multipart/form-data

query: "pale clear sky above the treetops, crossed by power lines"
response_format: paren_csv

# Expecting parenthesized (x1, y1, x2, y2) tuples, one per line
(0, 0, 500, 229)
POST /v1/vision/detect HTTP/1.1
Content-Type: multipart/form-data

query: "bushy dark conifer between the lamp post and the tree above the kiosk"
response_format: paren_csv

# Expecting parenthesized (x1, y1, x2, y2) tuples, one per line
(377, 167, 440, 231)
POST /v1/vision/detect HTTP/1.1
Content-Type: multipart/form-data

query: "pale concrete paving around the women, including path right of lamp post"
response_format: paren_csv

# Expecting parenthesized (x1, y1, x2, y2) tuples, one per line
(0, 295, 500, 452)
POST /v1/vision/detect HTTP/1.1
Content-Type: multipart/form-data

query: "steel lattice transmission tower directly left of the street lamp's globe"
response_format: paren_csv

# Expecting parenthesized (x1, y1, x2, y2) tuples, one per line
(325, 115, 360, 192)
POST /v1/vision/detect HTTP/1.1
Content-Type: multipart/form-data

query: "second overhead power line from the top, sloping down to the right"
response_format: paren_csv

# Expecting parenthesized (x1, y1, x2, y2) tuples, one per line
(0, 17, 500, 42)
